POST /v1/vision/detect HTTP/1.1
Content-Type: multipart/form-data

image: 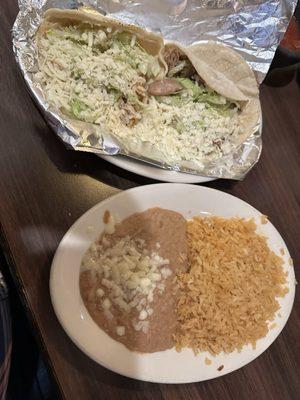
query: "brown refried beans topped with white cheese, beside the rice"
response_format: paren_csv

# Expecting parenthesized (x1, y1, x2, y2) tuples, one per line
(79, 208, 188, 353)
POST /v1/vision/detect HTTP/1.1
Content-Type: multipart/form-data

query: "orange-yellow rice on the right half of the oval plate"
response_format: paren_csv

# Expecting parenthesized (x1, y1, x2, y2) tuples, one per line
(174, 217, 288, 354)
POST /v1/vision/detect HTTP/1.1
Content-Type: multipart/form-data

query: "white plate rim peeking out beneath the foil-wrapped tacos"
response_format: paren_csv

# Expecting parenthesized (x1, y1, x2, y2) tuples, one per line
(99, 154, 216, 183)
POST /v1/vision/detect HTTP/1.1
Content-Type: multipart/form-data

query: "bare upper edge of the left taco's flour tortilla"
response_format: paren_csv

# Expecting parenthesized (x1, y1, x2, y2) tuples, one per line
(37, 7, 167, 78)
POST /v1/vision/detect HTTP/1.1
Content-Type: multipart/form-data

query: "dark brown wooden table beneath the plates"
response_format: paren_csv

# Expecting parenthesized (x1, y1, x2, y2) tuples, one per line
(0, 0, 300, 400)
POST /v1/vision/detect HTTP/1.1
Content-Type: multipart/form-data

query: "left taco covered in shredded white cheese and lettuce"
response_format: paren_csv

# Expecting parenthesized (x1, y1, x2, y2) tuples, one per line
(35, 9, 166, 129)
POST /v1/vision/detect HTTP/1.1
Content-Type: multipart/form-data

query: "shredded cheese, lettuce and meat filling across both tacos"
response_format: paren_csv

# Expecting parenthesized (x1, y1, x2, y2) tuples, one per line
(35, 12, 255, 163)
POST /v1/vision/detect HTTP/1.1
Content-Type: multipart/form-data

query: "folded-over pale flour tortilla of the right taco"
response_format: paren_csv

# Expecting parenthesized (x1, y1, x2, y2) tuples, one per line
(165, 42, 261, 146)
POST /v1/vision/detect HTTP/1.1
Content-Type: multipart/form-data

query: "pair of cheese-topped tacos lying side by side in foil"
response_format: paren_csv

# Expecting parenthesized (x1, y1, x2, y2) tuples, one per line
(35, 9, 260, 166)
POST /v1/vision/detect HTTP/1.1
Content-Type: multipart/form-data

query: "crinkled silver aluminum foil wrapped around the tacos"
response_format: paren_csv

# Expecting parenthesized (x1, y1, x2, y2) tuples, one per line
(12, 0, 297, 179)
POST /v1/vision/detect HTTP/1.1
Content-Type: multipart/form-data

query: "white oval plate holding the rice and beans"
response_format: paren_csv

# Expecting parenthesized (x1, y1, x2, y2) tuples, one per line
(50, 184, 295, 383)
